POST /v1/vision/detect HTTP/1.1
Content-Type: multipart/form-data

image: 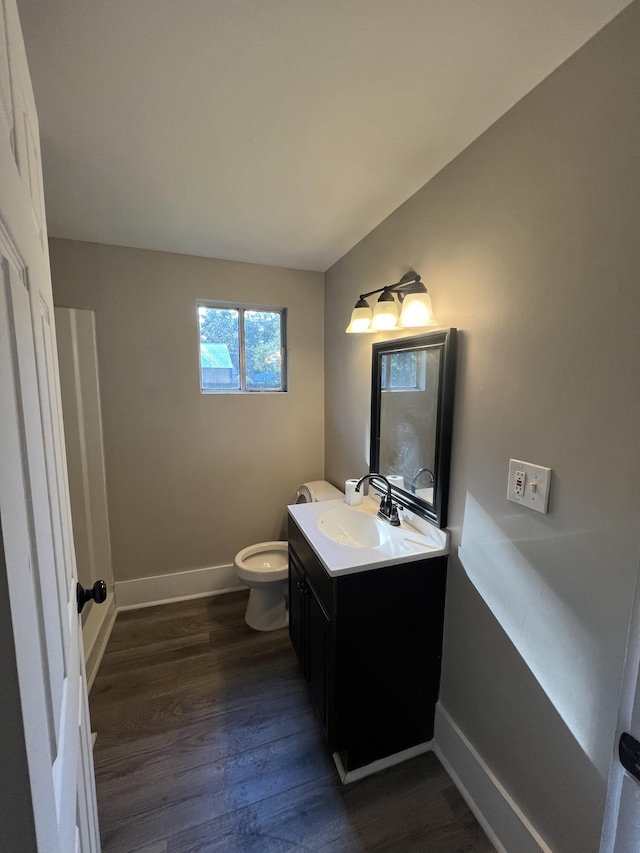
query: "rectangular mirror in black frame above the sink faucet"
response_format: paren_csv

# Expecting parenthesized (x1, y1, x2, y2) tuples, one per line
(370, 329, 456, 527)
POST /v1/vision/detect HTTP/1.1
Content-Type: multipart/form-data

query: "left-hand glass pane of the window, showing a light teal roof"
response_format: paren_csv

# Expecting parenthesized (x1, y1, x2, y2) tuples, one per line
(198, 305, 240, 391)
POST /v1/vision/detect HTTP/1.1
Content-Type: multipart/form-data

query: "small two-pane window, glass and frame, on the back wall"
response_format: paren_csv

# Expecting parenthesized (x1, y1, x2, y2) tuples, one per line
(198, 302, 287, 394)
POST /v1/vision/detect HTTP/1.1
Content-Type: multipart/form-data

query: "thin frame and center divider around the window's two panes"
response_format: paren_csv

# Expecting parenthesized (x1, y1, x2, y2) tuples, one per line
(196, 299, 289, 395)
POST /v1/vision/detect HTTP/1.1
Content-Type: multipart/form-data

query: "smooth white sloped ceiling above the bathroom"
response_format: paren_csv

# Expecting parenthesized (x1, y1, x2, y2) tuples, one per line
(18, 0, 629, 271)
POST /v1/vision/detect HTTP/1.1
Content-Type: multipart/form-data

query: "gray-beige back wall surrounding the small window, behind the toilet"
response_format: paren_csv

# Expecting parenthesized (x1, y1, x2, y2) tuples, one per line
(50, 239, 324, 581)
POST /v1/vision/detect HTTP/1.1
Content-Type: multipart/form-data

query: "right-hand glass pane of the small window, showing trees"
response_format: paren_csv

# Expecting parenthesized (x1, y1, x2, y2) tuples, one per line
(244, 310, 282, 391)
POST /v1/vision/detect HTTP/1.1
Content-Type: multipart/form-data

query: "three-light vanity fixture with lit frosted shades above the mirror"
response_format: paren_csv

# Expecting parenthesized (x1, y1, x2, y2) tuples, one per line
(346, 270, 439, 333)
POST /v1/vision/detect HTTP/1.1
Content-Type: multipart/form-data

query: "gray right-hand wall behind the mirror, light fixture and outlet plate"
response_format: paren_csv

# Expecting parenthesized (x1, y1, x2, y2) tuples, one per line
(325, 3, 640, 853)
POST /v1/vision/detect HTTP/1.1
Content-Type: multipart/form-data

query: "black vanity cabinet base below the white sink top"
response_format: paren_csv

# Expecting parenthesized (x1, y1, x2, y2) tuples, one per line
(289, 518, 447, 771)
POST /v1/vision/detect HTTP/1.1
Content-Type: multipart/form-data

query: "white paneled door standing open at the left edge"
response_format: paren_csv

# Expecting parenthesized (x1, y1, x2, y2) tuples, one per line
(0, 0, 100, 853)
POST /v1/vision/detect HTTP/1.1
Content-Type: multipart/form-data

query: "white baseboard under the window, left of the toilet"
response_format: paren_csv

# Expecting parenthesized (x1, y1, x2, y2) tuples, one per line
(115, 565, 246, 610)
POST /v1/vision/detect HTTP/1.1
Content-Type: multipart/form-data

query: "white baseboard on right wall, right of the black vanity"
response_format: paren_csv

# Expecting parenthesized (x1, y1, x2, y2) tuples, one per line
(433, 703, 553, 853)
